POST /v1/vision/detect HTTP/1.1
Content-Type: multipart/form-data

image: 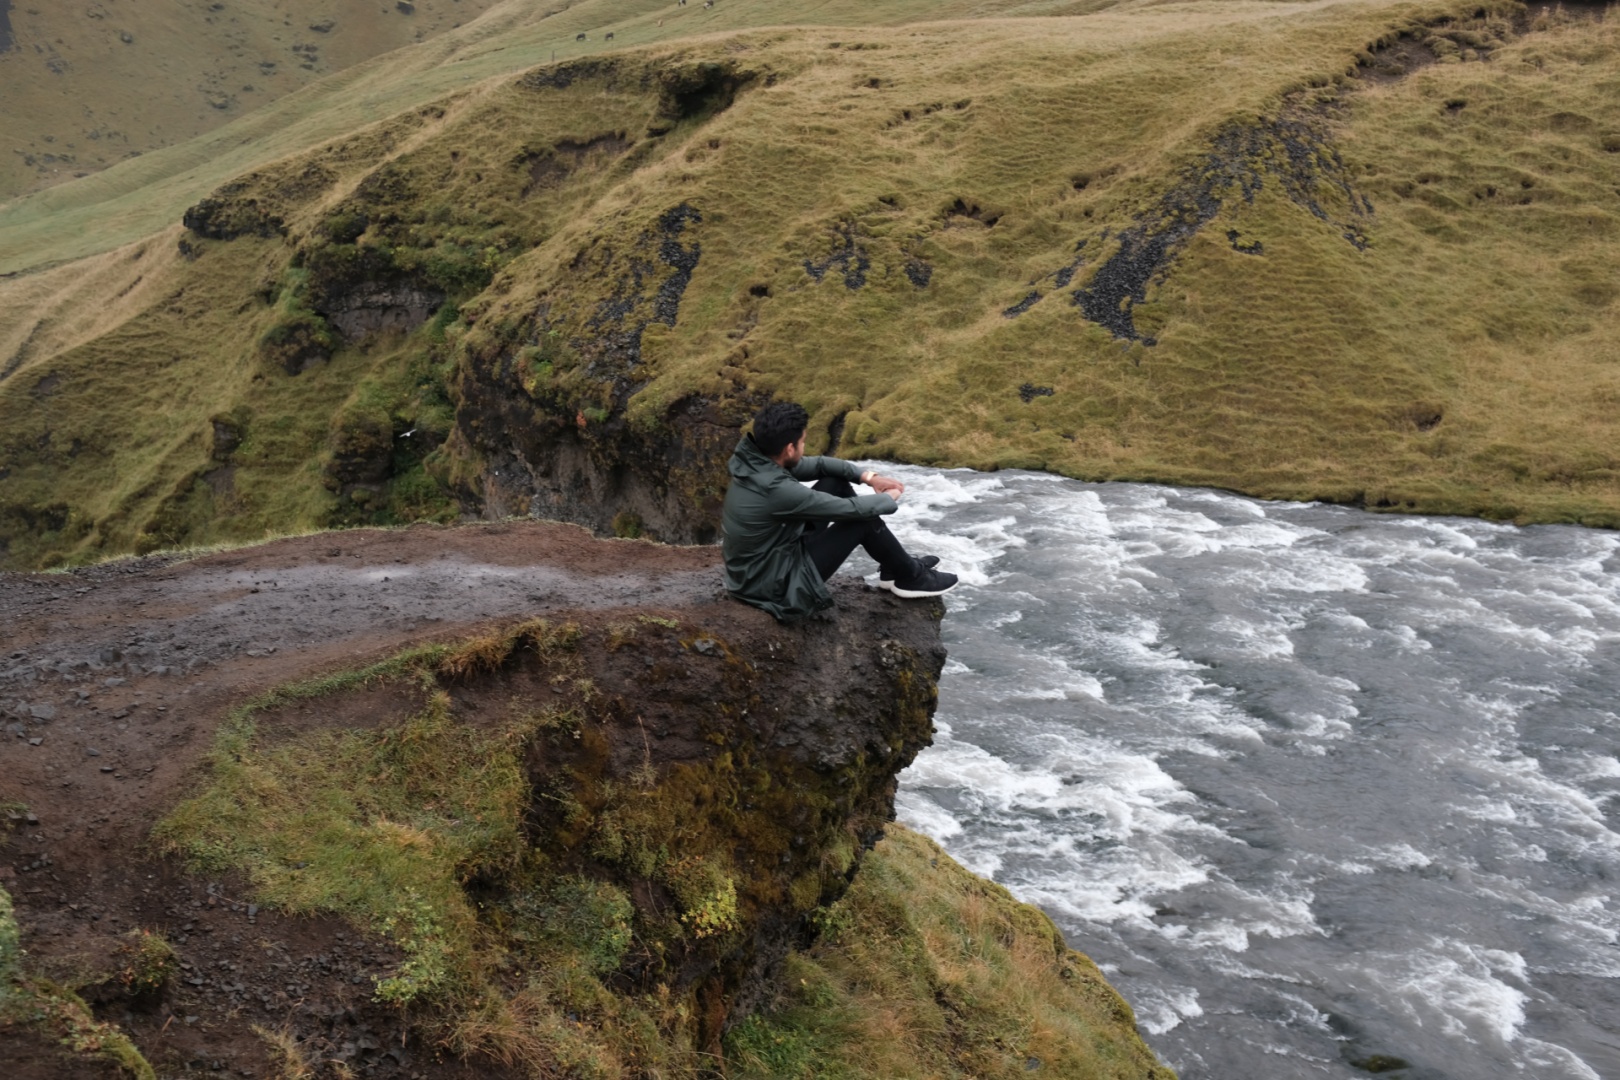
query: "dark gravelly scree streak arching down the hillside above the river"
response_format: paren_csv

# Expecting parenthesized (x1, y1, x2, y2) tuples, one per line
(1074, 113, 1372, 345)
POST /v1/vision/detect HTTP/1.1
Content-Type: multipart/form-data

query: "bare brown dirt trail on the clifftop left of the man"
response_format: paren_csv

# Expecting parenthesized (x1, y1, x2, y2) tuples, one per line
(0, 523, 732, 1080)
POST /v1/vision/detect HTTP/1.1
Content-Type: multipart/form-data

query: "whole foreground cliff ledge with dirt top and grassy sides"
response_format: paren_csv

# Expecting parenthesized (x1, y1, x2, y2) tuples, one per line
(0, 523, 1168, 1078)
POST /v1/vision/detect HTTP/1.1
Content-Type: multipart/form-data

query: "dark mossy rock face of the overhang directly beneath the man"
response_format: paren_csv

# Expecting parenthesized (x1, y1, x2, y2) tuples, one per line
(511, 585, 944, 1049)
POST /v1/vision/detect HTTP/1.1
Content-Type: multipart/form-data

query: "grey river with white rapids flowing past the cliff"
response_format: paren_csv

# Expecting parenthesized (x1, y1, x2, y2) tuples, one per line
(857, 465, 1620, 1080)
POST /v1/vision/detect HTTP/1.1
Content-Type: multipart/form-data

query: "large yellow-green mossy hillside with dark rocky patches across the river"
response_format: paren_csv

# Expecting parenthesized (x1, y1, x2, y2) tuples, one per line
(0, 0, 1620, 565)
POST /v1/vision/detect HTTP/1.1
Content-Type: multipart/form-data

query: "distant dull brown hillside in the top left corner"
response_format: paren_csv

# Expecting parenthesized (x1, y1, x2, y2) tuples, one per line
(0, 0, 497, 201)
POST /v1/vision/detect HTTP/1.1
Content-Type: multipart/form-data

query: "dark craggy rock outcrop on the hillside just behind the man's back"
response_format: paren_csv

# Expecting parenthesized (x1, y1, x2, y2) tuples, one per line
(450, 202, 758, 544)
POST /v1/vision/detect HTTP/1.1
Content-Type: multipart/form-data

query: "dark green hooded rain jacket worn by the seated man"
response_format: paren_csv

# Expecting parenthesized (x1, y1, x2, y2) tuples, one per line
(721, 436, 899, 622)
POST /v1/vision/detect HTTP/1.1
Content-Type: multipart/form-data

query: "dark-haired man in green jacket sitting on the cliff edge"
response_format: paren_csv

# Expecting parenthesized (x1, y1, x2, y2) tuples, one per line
(721, 402, 956, 620)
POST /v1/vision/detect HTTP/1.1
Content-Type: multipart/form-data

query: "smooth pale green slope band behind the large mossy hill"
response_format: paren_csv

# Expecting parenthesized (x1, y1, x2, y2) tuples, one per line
(0, 0, 1113, 275)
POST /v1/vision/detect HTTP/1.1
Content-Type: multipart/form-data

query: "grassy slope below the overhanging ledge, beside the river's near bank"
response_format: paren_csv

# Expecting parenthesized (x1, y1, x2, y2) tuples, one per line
(726, 826, 1173, 1080)
